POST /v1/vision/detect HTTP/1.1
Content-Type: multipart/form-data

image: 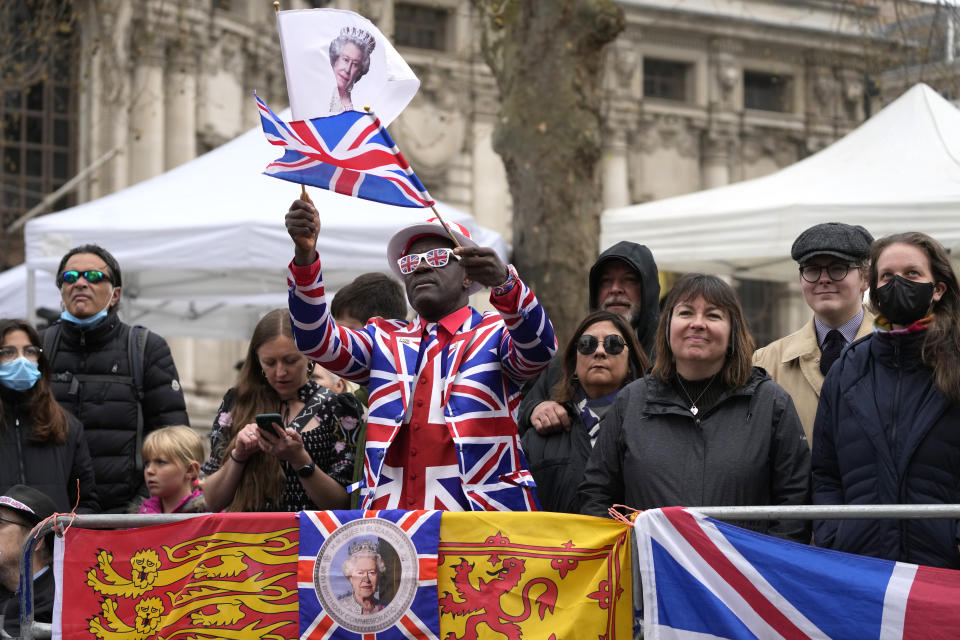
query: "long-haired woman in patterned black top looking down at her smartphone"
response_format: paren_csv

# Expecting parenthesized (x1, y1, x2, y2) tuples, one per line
(202, 309, 362, 511)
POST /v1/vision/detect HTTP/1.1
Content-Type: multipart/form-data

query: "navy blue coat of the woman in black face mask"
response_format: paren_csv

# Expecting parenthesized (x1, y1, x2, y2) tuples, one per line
(812, 332, 960, 569)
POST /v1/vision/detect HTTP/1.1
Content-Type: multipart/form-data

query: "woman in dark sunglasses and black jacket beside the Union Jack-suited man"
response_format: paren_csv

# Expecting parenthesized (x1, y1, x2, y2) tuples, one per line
(522, 311, 649, 513)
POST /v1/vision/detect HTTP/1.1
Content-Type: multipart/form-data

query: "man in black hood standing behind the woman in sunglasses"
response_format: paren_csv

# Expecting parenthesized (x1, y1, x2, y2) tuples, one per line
(517, 240, 660, 436)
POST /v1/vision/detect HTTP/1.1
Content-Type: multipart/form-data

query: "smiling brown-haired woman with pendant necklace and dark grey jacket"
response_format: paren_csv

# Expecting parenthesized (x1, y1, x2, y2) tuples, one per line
(580, 274, 810, 542)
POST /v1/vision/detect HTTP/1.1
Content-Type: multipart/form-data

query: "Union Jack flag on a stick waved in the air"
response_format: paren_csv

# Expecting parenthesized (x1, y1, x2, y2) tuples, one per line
(254, 96, 434, 207)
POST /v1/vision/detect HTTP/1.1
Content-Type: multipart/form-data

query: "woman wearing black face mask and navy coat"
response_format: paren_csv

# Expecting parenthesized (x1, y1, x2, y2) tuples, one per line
(813, 232, 960, 569)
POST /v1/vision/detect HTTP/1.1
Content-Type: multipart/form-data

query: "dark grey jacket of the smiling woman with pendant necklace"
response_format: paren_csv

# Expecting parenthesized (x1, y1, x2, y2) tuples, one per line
(580, 367, 810, 542)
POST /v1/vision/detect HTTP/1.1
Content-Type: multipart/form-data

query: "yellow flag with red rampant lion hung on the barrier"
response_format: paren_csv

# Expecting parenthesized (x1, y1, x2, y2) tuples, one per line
(437, 512, 633, 640)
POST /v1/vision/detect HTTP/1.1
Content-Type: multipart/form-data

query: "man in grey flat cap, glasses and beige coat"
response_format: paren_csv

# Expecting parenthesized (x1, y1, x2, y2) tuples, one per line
(753, 222, 873, 443)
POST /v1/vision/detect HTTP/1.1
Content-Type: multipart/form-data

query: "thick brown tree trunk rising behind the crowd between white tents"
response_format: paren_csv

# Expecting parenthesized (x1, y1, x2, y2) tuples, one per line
(473, 0, 625, 345)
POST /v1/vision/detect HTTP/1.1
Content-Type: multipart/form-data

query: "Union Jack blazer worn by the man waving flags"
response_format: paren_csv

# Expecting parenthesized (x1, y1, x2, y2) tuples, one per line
(287, 259, 557, 511)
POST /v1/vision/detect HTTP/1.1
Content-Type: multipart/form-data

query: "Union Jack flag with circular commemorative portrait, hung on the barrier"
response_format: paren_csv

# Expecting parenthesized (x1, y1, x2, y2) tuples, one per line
(297, 510, 441, 640)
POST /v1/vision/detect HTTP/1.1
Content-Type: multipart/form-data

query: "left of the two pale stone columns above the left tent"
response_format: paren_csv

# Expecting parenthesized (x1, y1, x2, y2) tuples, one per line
(128, 29, 166, 184)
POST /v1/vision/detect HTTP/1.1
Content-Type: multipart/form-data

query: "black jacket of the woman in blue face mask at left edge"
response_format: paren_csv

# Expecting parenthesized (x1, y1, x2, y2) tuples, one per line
(0, 387, 100, 513)
